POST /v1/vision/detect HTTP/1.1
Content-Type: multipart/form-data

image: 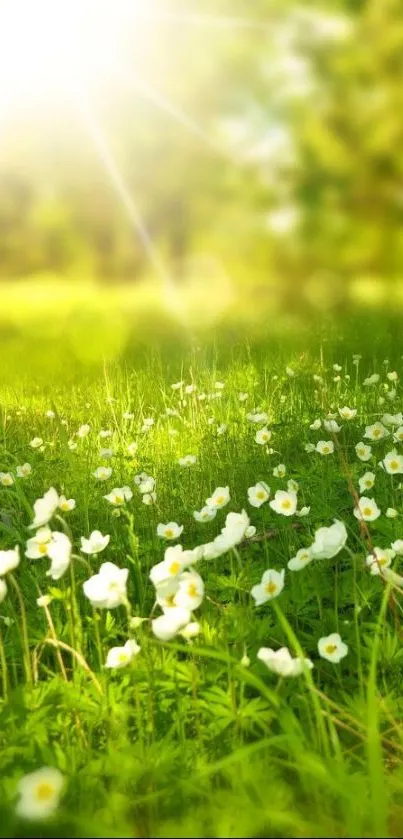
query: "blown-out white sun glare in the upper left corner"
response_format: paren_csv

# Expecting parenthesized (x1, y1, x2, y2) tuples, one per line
(0, 0, 158, 115)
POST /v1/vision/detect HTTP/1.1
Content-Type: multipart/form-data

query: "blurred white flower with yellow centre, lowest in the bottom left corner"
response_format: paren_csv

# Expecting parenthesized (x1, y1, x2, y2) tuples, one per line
(15, 766, 64, 820)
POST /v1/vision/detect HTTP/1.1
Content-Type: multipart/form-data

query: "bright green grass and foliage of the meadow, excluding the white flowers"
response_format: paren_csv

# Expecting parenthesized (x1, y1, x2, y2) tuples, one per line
(0, 304, 403, 837)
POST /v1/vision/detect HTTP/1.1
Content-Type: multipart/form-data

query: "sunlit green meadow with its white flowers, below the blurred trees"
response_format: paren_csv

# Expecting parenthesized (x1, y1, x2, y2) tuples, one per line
(0, 286, 403, 839)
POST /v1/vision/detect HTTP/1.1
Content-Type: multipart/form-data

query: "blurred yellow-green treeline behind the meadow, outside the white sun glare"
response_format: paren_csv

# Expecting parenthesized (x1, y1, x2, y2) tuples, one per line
(0, 0, 403, 303)
